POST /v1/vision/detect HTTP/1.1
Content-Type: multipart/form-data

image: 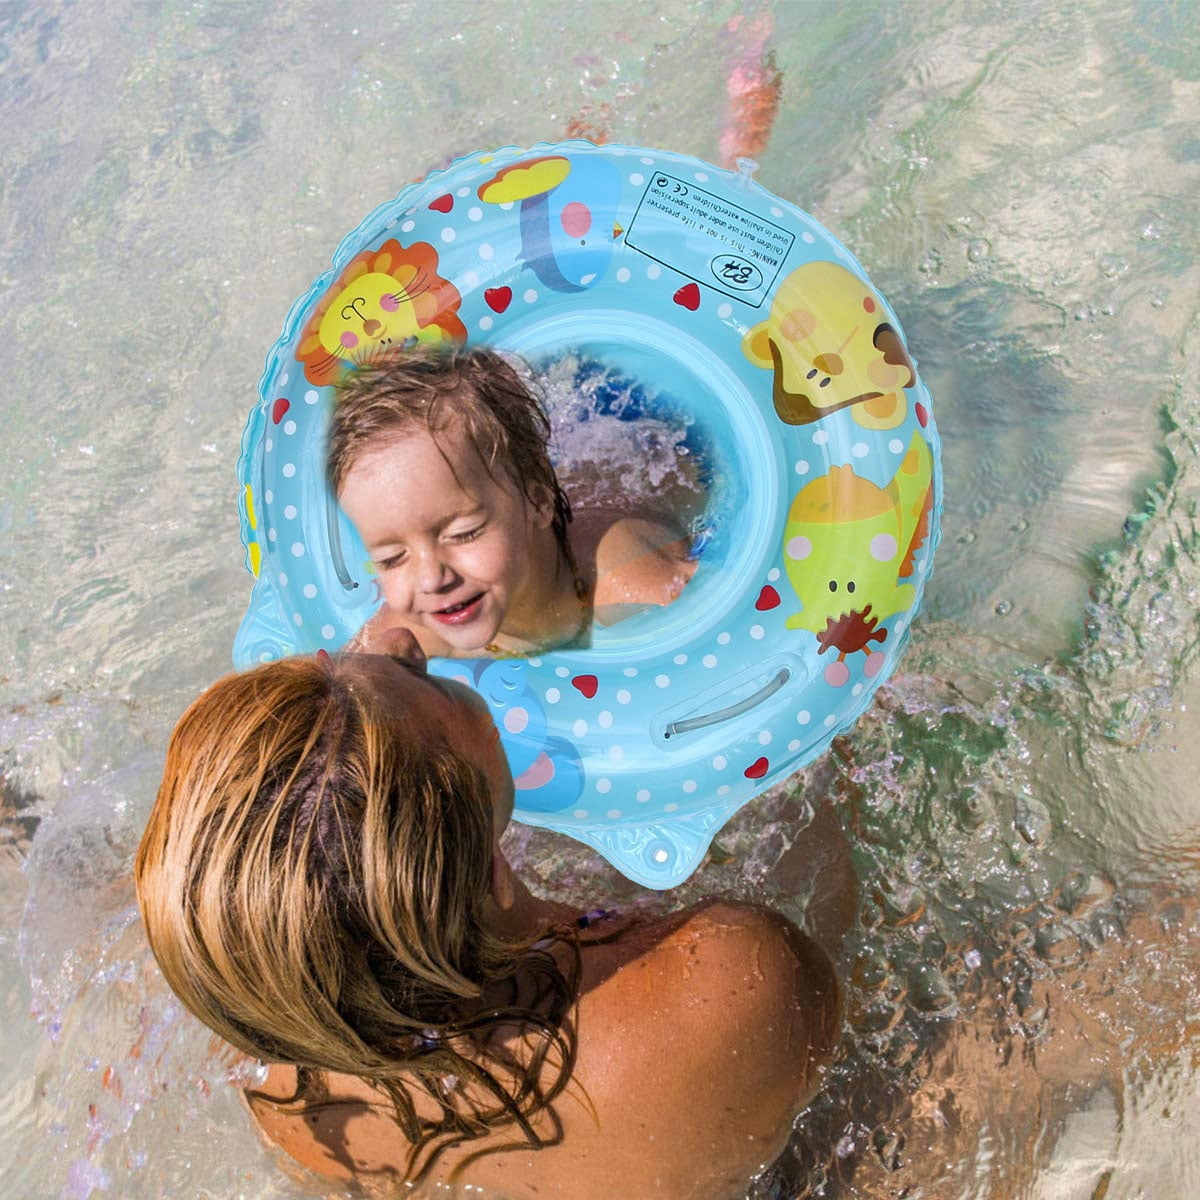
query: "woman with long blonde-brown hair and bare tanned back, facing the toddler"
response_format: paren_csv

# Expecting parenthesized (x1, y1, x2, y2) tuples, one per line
(136, 631, 839, 1200)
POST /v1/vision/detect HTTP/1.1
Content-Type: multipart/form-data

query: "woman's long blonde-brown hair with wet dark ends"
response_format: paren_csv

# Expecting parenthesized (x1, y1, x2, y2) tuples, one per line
(134, 655, 578, 1177)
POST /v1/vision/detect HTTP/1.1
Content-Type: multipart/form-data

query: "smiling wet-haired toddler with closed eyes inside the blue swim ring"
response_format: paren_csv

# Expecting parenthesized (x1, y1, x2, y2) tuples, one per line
(328, 346, 695, 658)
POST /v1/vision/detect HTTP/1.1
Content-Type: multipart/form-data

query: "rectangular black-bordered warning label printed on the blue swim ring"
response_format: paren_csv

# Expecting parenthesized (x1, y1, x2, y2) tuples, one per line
(625, 173, 796, 308)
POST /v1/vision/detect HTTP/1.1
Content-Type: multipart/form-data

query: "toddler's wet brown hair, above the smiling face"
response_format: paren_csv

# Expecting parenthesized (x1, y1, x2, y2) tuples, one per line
(325, 344, 574, 556)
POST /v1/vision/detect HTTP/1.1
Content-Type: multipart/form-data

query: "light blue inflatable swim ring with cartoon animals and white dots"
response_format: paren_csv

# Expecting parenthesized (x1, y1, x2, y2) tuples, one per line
(234, 142, 942, 888)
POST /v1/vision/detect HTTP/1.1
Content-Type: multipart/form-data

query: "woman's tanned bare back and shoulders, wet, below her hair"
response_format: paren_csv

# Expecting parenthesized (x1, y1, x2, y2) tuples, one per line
(252, 902, 840, 1200)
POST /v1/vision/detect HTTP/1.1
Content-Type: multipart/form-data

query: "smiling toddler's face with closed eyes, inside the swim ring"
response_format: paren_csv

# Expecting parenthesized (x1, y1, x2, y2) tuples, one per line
(338, 426, 552, 652)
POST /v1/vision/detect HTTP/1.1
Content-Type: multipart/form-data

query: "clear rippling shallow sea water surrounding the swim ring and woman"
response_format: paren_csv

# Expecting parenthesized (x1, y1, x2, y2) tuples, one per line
(0, 0, 1200, 1200)
